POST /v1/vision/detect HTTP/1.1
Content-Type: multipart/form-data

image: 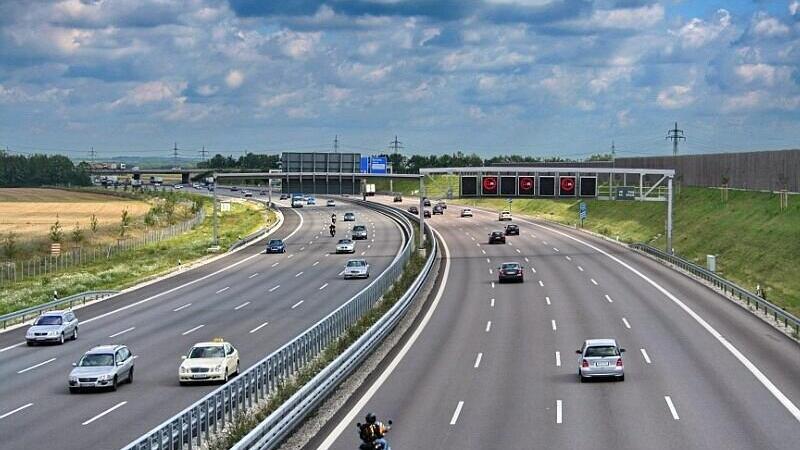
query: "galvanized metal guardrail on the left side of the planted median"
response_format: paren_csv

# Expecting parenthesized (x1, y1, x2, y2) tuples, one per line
(123, 200, 414, 450)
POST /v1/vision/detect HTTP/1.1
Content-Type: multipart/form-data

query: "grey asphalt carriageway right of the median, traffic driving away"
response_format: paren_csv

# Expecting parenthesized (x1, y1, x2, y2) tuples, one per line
(306, 197, 800, 450)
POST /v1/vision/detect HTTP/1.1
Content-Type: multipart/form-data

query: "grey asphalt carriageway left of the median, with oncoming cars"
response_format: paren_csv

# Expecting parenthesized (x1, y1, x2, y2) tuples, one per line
(0, 193, 403, 450)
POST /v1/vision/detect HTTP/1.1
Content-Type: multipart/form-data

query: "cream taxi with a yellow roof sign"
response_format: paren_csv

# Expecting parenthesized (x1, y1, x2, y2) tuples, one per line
(178, 338, 239, 385)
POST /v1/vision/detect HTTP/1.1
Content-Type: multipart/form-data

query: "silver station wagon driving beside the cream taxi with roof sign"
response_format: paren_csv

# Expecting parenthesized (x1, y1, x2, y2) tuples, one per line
(67, 345, 135, 394)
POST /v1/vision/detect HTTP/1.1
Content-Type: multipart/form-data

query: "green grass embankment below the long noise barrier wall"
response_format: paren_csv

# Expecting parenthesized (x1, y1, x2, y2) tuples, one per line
(454, 187, 800, 315)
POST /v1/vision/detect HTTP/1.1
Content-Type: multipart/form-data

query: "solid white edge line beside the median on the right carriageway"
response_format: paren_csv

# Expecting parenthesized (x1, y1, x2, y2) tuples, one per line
(317, 227, 451, 450)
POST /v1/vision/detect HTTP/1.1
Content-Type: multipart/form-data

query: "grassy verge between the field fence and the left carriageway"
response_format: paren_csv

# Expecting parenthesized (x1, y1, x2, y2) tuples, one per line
(0, 204, 276, 314)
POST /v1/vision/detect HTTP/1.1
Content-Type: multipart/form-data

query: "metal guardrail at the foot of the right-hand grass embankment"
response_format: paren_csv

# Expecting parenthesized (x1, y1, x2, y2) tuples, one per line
(630, 244, 800, 337)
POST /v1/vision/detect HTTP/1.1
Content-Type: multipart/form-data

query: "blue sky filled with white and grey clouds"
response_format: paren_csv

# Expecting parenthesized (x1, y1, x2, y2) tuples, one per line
(0, 0, 800, 157)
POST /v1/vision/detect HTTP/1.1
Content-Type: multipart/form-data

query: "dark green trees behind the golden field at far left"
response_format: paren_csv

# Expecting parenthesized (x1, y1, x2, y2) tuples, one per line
(0, 151, 91, 187)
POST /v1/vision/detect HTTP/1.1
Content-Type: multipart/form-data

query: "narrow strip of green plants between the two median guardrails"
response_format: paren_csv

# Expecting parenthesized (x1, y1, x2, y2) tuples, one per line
(207, 244, 430, 450)
